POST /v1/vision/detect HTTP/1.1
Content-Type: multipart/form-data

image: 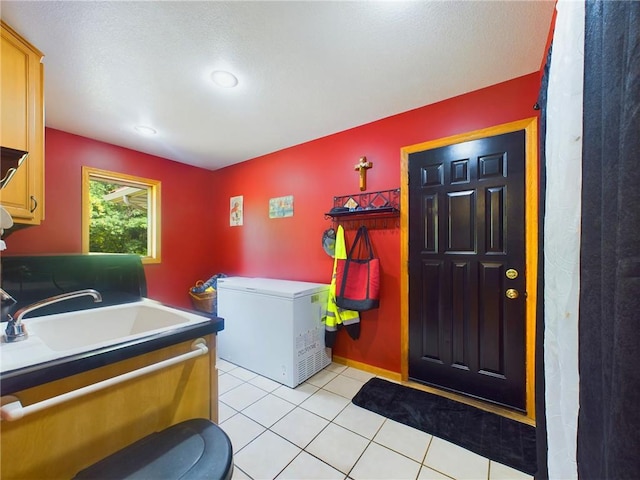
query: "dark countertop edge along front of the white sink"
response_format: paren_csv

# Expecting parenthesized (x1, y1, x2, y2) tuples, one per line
(0, 312, 224, 395)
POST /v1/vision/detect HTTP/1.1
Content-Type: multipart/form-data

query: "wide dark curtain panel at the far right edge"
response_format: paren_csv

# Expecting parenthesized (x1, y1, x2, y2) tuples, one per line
(577, 1, 640, 480)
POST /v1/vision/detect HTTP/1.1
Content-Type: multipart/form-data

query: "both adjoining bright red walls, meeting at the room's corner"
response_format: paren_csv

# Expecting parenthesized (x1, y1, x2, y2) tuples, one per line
(7, 72, 540, 372)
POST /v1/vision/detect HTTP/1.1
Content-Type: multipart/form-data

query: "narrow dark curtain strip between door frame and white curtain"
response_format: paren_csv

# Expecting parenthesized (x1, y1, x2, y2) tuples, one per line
(535, 47, 553, 480)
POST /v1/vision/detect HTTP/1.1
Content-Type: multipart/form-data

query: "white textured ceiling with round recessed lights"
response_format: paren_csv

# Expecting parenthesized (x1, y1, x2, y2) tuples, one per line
(0, 0, 555, 170)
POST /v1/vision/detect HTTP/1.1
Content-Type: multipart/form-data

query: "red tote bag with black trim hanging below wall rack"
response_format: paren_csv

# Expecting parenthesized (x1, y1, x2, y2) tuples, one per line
(336, 225, 380, 312)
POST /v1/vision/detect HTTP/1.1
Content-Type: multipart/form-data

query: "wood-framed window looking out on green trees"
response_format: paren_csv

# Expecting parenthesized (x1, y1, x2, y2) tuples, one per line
(82, 167, 161, 263)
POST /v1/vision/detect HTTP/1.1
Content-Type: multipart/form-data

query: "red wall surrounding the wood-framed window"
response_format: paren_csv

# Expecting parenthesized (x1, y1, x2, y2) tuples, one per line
(3, 128, 220, 307)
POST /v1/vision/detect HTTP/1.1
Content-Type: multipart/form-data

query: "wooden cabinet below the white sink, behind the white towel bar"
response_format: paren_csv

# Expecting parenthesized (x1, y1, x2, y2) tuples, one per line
(0, 334, 218, 480)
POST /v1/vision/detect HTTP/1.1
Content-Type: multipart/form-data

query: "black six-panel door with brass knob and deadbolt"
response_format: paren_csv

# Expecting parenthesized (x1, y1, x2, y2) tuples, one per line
(409, 130, 526, 411)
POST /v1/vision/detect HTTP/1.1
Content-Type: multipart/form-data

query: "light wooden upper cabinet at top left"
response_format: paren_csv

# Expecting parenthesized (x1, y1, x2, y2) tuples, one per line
(0, 22, 44, 225)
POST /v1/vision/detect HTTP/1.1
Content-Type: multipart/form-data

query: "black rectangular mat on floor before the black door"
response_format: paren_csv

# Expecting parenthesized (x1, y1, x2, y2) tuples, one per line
(352, 378, 537, 475)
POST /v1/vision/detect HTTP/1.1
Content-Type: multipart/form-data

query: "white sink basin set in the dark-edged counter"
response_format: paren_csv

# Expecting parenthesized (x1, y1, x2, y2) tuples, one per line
(0, 299, 209, 372)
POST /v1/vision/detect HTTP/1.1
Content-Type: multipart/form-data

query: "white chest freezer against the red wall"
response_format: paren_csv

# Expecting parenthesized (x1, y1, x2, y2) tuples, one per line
(217, 277, 331, 388)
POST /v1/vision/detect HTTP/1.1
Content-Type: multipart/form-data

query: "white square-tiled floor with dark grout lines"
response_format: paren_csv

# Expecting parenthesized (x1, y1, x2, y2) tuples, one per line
(218, 360, 533, 480)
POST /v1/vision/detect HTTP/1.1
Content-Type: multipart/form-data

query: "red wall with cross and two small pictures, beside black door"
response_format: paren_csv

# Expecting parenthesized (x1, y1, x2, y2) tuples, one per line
(211, 72, 540, 372)
